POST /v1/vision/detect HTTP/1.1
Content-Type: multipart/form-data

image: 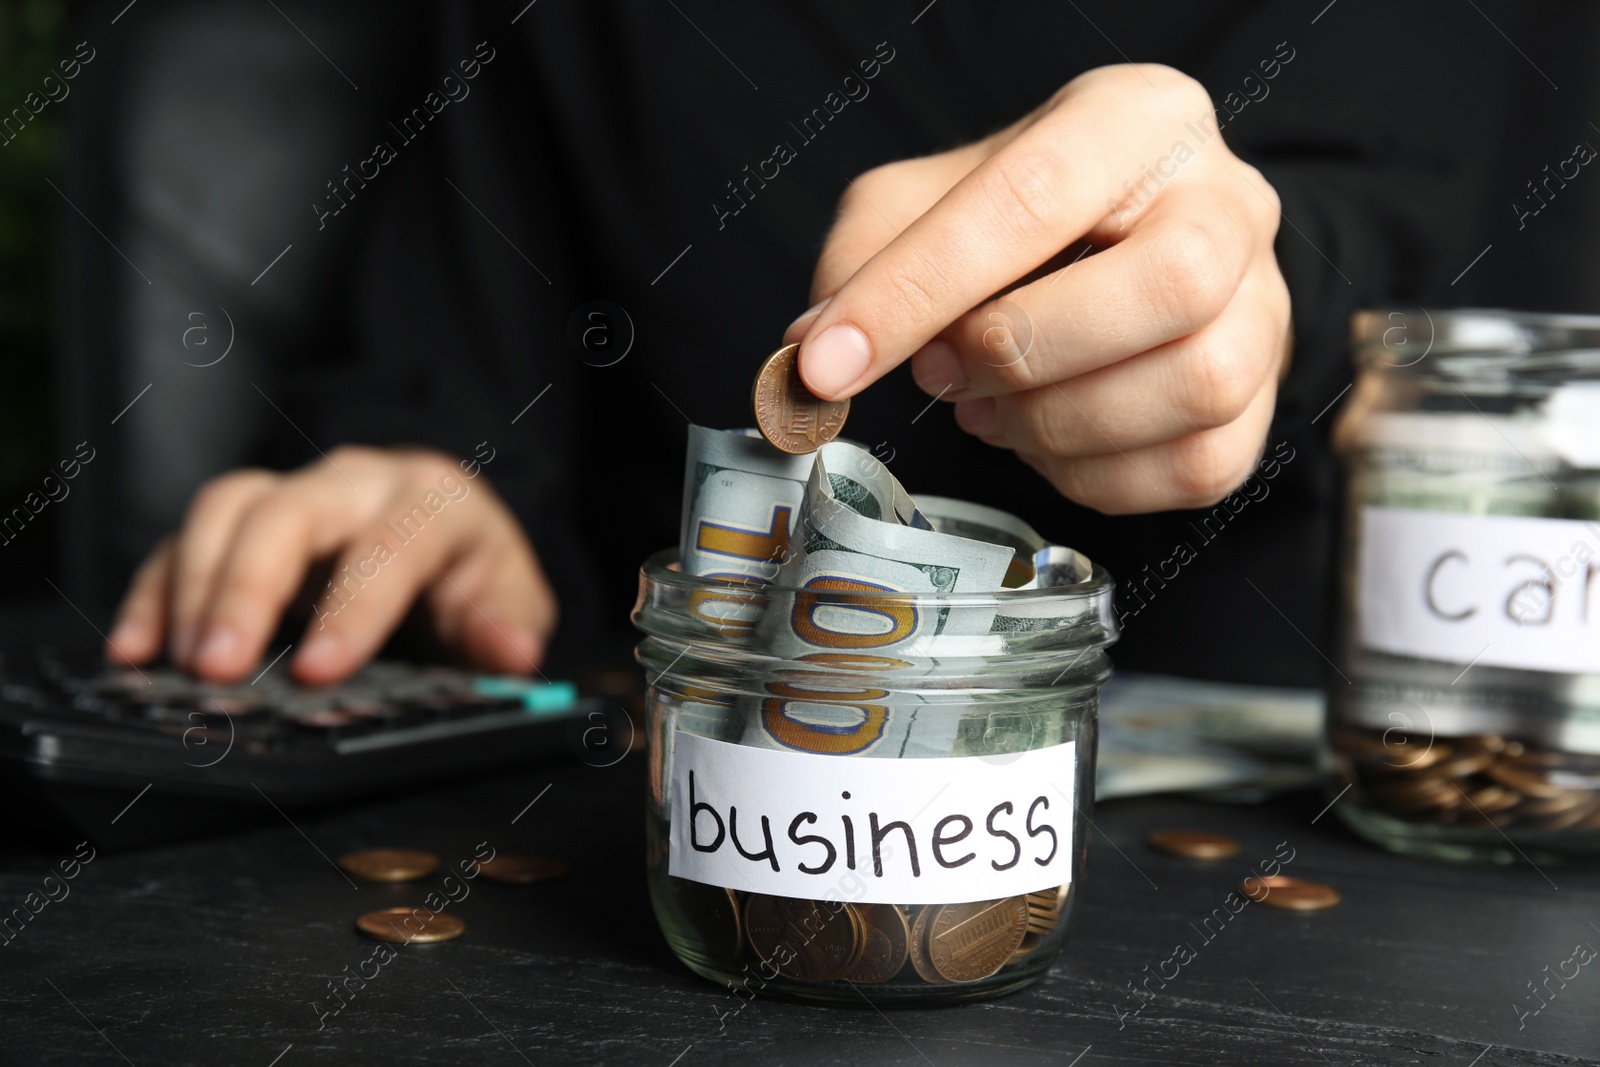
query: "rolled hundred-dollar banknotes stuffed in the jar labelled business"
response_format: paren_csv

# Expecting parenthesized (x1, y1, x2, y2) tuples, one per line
(662, 427, 1090, 758)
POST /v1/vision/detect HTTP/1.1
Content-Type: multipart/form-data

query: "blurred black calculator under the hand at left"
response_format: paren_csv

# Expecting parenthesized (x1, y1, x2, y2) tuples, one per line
(0, 646, 635, 846)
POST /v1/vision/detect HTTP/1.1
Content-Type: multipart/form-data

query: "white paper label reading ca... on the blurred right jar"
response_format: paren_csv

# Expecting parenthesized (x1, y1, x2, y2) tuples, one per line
(1357, 507, 1600, 673)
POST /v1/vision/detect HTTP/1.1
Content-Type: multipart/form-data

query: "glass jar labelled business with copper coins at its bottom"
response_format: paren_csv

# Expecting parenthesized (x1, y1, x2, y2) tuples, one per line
(634, 547, 1117, 1006)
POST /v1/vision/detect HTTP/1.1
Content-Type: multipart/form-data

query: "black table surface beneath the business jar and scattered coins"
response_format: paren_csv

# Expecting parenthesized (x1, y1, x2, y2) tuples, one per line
(0, 752, 1600, 1067)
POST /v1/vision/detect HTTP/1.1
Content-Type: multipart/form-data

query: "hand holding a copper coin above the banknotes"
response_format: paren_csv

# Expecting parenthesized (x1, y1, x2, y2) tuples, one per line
(786, 66, 1291, 512)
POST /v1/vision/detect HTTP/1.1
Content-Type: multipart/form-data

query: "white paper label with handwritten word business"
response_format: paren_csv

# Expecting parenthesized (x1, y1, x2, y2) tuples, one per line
(667, 731, 1077, 904)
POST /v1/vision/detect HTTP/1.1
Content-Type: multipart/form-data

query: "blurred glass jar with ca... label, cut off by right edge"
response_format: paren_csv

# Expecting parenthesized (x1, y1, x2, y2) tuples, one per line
(1328, 309, 1600, 864)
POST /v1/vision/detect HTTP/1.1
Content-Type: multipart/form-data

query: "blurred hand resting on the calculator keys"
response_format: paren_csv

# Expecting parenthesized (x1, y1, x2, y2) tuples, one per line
(107, 446, 557, 685)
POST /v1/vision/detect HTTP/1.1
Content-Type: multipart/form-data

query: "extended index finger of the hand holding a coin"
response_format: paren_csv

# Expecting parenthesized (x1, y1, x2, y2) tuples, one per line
(800, 67, 1210, 400)
